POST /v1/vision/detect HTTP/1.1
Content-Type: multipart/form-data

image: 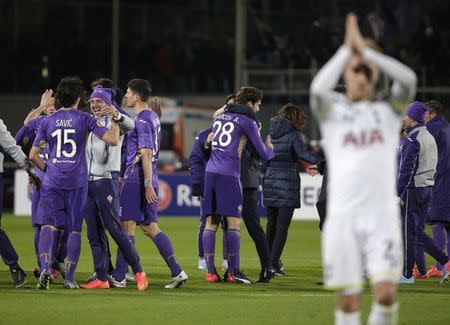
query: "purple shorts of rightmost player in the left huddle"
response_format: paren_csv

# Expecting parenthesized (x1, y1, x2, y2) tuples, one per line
(119, 180, 159, 225)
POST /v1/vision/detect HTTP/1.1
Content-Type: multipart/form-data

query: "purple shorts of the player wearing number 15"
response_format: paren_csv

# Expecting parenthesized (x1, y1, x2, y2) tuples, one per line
(38, 185, 88, 232)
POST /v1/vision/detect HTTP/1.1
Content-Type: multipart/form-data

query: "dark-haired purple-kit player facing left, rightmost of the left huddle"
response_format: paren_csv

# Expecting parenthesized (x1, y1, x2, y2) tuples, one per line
(113, 79, 188, 289)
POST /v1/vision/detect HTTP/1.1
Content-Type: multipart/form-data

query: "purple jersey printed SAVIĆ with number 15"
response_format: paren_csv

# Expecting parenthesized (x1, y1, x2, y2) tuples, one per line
(33, 108, 108, 190)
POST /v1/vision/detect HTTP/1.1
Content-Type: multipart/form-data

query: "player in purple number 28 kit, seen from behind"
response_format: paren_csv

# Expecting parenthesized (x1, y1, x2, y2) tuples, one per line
(203, 87, 274, 284)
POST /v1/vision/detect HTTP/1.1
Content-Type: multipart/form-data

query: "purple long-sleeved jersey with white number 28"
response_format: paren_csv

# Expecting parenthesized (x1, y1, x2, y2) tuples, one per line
(206, 112, 274, 178)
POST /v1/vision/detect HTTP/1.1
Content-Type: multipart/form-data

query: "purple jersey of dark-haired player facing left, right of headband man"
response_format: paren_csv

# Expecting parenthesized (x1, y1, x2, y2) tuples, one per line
(125, 109, 161, 188)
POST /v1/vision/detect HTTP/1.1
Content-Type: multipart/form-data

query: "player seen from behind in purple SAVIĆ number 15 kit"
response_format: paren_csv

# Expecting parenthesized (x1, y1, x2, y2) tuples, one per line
(30, 77, 119, 289)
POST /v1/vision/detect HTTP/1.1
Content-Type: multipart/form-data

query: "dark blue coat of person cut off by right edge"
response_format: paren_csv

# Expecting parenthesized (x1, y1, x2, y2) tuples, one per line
(427, 116, 450, 222)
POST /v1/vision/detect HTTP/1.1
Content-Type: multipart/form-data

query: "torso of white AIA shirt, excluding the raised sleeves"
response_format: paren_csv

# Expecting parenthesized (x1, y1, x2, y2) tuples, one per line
(321, 98, 401, 214)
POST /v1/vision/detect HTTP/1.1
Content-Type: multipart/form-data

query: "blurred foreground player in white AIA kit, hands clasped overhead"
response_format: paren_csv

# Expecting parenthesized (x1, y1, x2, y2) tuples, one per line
(311, 14, 417, 325)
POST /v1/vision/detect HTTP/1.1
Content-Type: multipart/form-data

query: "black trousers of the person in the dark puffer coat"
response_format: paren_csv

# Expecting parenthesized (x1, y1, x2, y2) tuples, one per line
(266, 207, 294, 265)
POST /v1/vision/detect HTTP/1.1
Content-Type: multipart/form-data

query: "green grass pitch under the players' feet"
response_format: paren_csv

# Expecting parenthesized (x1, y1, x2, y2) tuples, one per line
(0, 214, 450, 325)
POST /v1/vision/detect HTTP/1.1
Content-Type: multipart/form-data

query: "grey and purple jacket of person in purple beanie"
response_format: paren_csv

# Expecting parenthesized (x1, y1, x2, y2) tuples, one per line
(397, 124, 437, 196)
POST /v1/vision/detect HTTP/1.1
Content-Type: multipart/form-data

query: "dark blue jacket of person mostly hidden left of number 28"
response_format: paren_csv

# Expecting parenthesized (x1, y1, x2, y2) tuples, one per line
(189, 128, 212, 196)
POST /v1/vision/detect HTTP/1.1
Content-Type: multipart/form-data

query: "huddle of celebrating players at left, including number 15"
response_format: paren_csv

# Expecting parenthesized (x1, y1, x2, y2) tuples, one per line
(10, 77, 188, 290)
